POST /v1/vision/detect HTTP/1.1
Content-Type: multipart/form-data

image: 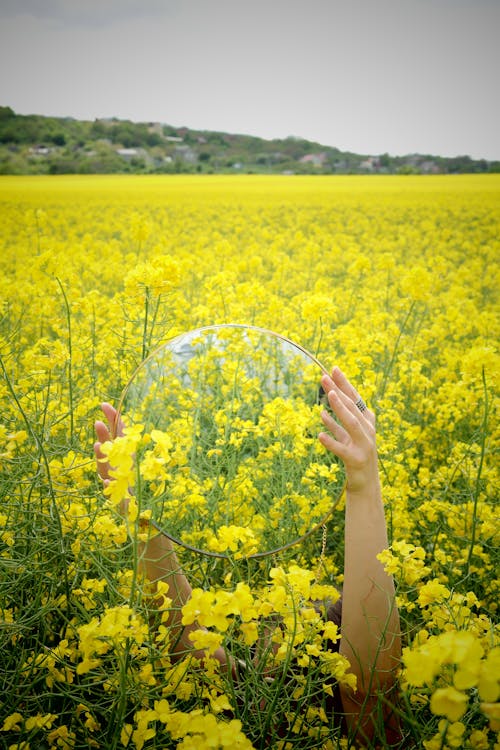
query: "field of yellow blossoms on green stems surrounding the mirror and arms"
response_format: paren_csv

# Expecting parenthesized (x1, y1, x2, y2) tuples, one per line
(0, 175, 500, 750)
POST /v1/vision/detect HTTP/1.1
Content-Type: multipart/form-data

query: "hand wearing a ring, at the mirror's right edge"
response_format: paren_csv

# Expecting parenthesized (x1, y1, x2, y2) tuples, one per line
(319, 367, 378, 493)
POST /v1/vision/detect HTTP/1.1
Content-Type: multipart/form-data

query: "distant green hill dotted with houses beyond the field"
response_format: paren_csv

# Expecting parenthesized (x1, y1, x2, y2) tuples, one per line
(0, 107, 500, 174)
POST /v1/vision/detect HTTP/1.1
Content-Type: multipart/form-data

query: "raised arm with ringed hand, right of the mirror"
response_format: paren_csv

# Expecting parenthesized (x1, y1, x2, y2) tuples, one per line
(319, 368, 401, 738)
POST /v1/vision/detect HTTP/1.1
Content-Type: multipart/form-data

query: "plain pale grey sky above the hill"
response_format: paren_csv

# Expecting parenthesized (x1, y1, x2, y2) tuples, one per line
(0, 0, 500, 159)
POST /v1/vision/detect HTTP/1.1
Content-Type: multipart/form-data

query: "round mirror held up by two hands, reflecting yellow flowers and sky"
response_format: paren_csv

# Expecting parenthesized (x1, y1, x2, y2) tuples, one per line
(118, 324, 344, 559)
